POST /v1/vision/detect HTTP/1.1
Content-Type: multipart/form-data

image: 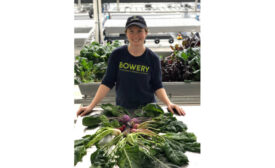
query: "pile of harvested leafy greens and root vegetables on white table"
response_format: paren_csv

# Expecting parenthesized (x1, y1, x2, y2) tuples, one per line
(74, 104, 200, 168)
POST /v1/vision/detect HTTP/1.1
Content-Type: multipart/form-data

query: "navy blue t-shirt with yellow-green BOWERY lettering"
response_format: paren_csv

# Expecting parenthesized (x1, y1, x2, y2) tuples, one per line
(102, 45, 163, 109)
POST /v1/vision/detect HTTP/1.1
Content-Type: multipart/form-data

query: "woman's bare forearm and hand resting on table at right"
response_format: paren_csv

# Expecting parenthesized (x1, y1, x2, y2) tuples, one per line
(155, 88, 185, 115)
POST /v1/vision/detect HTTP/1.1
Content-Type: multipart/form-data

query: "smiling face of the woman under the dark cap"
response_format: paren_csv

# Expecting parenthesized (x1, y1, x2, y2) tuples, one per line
(126, 26, 147, 45)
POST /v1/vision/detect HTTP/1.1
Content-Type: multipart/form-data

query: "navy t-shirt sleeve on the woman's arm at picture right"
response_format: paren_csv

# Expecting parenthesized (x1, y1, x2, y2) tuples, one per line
(152, 55, 163, 92)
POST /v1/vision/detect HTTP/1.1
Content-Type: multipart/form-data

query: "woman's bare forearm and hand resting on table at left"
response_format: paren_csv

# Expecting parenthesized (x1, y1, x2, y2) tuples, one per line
(76, 84, 111, 116)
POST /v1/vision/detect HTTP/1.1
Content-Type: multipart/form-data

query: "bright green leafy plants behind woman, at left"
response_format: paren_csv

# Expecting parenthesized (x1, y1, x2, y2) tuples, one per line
(74, 41, 120, 84)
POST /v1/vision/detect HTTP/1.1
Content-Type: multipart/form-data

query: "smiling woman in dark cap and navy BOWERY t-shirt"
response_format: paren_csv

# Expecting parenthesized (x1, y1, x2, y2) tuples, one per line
(77, 16, 185, 116)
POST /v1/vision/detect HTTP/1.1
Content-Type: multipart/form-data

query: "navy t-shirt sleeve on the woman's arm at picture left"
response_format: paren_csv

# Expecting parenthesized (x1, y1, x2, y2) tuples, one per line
(101, 52, 117, 89)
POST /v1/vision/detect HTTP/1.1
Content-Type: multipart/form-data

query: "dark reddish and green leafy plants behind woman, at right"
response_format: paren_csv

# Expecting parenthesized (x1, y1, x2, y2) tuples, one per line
(161, 33, 200, 82)
